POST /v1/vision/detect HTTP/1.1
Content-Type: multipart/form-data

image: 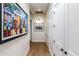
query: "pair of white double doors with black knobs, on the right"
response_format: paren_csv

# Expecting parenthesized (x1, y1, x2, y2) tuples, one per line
(53, 3, 79, 56)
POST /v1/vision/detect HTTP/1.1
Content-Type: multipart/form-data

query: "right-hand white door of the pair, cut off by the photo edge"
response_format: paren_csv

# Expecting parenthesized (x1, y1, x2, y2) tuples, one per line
(64, 3, 79, 56)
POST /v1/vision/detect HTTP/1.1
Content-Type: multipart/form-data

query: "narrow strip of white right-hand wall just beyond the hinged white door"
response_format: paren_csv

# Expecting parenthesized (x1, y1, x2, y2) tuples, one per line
(46, 4, 54, 55)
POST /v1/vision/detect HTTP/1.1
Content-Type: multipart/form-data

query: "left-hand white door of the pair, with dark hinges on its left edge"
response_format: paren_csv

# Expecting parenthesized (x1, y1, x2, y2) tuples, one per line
(53, 4, 65, 56)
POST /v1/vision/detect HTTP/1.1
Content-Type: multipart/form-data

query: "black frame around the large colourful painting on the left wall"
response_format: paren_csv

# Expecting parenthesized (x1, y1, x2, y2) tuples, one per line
(0, 3, 28, 44)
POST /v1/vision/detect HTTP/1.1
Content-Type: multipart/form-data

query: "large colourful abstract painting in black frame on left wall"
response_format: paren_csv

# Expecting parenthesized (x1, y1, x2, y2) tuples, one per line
(0, 3, 28, 43)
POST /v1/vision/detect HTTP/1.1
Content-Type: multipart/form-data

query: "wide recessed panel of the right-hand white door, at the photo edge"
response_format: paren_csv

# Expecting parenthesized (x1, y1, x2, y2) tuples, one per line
(67, 3, 79, 56)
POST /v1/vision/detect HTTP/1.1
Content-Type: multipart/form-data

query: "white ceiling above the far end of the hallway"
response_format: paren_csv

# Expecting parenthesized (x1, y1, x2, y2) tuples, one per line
(29, 3, 49, 13)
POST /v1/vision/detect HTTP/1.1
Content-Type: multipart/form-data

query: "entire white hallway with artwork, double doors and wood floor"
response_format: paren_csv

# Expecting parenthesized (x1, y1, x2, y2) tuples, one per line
(0, 3, 79, 56)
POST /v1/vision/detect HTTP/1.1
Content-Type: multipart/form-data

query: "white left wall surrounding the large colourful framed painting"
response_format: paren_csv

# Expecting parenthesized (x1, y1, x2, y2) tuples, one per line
(0, 4, 30, 56)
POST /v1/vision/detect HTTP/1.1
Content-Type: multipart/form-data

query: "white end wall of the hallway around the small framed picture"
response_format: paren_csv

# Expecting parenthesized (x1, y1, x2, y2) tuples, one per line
(32, 14, 46, 42)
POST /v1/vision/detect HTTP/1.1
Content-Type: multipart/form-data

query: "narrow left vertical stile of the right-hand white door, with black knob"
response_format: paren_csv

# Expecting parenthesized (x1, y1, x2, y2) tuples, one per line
(63, 3, 69, 56)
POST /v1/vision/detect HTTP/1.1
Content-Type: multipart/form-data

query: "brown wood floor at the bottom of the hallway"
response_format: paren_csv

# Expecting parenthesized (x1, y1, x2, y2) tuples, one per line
(27, 42, 50, 56)
